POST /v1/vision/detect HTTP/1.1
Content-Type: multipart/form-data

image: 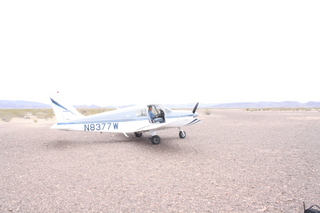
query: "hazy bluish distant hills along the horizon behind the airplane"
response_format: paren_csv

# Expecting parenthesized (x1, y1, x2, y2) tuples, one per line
(0, 100, 320, 109)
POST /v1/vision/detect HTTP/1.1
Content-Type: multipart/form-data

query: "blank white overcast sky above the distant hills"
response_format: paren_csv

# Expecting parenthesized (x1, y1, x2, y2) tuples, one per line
(0, 0, 320, 105)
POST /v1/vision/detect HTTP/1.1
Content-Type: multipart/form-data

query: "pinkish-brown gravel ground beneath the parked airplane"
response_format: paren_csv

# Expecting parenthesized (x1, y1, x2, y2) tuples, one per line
(0, 110, 320, 212)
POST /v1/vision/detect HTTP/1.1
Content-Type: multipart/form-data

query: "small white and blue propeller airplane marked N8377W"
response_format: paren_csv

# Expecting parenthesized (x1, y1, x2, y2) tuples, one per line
(50, 94, 201, 145)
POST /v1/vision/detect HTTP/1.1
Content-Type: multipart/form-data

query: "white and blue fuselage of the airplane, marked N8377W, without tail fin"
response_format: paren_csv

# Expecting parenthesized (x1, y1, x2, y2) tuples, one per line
(52, 105, 199, 133)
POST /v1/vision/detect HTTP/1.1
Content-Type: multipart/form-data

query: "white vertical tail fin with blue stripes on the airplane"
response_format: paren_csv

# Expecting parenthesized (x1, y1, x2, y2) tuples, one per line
(50, 95, 83, 123)
